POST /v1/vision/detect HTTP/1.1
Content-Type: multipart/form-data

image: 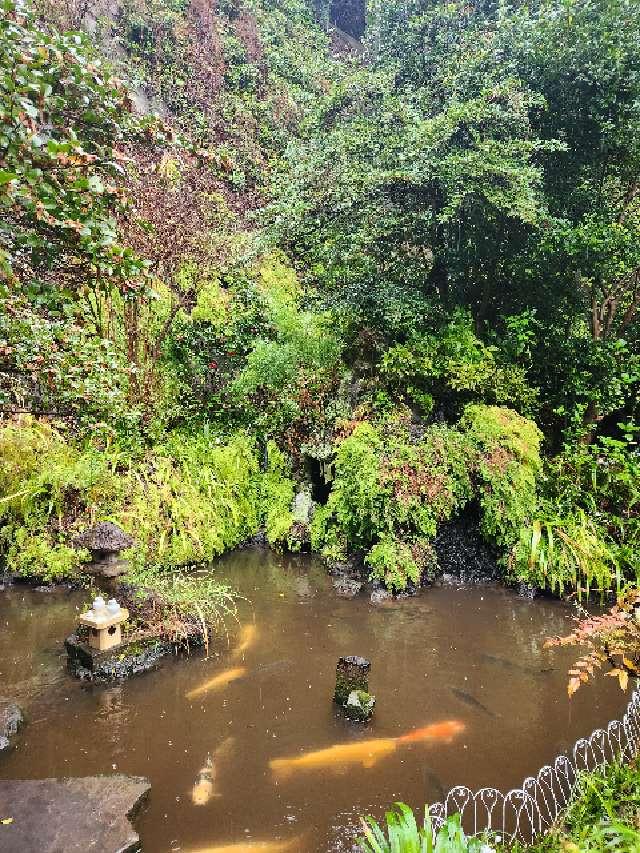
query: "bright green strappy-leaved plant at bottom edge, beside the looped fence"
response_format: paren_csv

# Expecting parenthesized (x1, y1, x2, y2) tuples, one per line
(358, 803, 489, 853)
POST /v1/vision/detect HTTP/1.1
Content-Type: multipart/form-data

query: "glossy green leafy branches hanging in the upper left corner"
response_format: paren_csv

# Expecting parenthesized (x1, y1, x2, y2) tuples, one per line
(0, 0, 143, 290)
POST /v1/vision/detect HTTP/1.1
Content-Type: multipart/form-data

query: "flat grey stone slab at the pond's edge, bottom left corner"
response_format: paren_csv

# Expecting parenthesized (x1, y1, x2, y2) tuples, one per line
(0, 774, 151, 853)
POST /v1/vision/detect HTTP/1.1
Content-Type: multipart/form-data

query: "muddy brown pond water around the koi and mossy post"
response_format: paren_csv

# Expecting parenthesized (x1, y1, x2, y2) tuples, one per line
(0, 550, 625, 853)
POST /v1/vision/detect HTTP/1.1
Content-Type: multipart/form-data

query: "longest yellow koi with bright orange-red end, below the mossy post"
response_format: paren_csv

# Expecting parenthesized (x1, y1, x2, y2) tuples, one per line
(269, 720, 465, 777)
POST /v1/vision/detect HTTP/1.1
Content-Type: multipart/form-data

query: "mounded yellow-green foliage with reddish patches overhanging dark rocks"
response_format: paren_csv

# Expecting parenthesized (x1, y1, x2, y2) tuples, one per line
(311, 405, 541, 589)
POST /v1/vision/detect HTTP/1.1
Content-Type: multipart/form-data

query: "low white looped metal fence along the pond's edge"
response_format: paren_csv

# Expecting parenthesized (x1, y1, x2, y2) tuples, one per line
(429, 687, 640, 843)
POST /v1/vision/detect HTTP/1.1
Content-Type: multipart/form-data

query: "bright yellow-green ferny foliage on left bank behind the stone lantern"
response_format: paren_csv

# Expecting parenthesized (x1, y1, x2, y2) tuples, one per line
(0, 421, 293, 577)
